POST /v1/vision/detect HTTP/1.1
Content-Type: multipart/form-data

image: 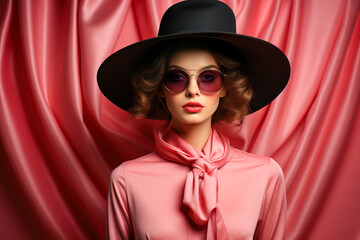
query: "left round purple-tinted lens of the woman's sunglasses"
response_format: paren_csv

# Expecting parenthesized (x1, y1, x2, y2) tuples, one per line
(164, 69, 189, 93)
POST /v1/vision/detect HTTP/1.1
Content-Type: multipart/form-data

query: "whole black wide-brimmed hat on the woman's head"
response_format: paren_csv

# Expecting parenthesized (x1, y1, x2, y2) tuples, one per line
(97, 0, 290, 118)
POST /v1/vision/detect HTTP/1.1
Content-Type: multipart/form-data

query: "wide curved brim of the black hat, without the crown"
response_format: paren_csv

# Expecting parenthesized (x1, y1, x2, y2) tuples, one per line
(97, 32, 290, 119)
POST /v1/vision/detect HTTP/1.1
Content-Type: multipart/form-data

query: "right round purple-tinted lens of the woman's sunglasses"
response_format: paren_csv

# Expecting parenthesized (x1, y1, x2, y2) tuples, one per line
(198, 70, 224, 93)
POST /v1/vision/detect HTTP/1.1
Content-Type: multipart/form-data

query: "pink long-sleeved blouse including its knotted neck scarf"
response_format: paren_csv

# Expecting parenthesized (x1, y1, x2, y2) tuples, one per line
(107, 127, 286, 240)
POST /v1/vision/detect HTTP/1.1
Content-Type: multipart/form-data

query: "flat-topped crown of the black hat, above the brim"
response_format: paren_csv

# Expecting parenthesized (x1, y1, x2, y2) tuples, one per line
(158, 0, 236, 36)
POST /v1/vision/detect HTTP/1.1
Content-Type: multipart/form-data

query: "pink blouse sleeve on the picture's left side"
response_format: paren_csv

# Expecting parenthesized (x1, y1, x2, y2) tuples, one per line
(106, 164, 133, 240)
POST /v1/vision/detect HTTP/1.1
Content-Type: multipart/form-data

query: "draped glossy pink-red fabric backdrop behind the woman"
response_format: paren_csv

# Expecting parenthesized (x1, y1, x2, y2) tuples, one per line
(0, 0, 360, 239)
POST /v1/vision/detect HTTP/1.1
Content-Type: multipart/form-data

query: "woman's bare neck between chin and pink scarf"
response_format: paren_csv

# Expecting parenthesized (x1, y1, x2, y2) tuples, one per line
(171, 119, 211, 151)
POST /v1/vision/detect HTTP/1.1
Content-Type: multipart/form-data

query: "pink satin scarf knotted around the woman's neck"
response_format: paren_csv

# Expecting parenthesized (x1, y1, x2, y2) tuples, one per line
(154, 129, 232, 239)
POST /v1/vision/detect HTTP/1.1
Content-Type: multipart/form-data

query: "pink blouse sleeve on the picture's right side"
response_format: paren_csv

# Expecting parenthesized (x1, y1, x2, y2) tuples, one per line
(255, 159, 287, 240)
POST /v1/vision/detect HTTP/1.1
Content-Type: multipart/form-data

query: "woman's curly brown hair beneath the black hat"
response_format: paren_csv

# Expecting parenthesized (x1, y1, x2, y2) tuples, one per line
(129, 39, 253, 125)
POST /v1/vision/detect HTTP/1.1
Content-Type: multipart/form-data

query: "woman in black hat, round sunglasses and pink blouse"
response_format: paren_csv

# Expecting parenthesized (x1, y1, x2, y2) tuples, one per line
(98, 0, 290, 239)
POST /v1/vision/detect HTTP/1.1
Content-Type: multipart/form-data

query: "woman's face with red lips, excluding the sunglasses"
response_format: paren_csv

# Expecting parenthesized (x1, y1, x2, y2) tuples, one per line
(163, 50, 226, 124)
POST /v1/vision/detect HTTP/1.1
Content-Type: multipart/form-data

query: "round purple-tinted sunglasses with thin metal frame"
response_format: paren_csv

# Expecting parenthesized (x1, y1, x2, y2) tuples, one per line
(163, 68, 226, 93)
